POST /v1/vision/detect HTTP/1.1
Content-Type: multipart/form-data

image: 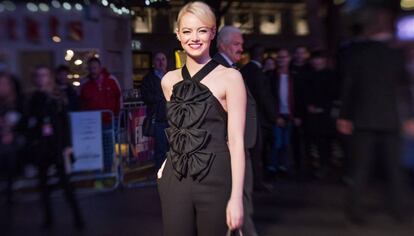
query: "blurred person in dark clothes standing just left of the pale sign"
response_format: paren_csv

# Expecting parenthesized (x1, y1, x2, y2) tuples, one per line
(25, 66, 84, 229)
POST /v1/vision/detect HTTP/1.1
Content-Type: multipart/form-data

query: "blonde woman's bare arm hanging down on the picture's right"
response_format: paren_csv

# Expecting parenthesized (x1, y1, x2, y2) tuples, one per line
(226, 70, 246, 229)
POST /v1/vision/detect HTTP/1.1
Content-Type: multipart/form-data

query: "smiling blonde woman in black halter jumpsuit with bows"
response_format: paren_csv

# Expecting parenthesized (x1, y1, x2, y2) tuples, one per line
(158, 2, 246, 236)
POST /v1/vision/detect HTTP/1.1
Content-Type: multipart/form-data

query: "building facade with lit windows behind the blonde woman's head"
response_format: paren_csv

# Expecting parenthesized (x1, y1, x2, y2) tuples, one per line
(131, 0, 321, 87)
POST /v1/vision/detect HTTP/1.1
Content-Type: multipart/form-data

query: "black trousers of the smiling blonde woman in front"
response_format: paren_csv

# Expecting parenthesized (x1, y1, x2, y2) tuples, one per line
(158, 151, 231, 236)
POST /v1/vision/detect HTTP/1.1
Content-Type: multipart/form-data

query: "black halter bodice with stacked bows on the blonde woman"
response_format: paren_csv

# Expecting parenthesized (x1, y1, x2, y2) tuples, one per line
(166, 60, 228, 180)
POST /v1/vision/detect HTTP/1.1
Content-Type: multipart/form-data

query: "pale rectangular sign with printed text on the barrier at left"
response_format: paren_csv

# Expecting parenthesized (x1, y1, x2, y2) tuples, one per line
(70, 111, 103, 172)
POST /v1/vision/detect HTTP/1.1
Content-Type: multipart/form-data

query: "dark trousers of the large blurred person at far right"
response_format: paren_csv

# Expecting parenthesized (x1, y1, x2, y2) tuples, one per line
(347, 130, 403, 215)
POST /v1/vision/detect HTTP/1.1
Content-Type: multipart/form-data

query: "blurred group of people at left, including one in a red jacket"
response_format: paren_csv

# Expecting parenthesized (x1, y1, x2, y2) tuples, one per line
(0, 58, 121, 228)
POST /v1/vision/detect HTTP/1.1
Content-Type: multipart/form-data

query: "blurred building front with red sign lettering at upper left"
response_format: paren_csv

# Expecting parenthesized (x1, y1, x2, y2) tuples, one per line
(0, 0, 132, 89)
